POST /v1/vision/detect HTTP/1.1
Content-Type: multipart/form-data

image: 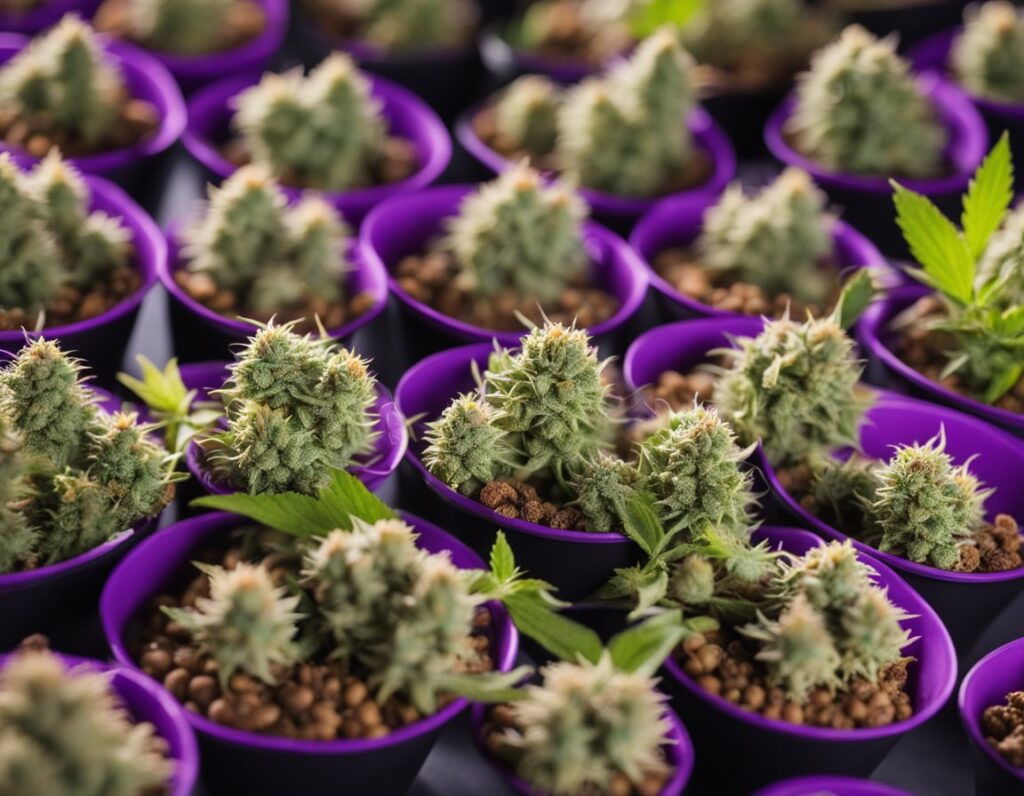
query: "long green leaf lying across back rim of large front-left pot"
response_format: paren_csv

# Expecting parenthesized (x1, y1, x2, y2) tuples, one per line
(191, 469, 397, 538)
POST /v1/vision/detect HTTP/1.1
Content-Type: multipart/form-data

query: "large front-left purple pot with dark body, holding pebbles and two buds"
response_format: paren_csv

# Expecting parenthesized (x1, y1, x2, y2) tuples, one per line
(100, 513, 518, 796)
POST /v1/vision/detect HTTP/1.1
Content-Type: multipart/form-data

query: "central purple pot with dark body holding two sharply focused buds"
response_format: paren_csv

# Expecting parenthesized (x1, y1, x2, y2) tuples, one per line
(395, 343, 640, 601)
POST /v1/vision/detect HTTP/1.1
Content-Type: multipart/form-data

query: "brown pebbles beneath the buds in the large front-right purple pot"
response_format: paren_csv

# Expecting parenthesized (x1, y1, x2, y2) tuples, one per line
(677, 628, 913, 729)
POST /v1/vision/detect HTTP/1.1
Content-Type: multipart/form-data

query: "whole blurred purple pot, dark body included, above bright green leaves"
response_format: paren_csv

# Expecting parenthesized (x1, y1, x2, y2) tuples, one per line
(765, 73, 988, 259)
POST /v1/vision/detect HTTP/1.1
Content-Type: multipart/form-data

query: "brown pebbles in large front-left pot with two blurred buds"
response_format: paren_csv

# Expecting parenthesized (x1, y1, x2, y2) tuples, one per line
(133, 547, 494, 741)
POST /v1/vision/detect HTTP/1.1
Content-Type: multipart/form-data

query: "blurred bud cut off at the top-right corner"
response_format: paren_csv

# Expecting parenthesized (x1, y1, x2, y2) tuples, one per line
(949, 0, 1024, 103)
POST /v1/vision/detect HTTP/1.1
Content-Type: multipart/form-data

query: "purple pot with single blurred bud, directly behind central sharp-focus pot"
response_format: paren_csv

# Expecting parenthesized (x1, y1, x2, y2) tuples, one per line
(359, 185, 647, 363)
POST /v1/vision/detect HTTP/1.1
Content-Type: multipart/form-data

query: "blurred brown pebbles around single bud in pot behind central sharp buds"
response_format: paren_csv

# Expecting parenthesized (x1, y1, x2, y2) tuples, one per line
(395, 251, 618, 332)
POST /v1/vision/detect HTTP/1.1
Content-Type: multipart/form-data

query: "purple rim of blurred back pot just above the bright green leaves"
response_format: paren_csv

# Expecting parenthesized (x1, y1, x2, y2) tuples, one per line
(765, 72, 988, 200)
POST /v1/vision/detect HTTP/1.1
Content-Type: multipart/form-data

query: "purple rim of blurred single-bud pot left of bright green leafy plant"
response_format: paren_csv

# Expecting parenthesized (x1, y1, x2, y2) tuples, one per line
(630, 189, 896, 318)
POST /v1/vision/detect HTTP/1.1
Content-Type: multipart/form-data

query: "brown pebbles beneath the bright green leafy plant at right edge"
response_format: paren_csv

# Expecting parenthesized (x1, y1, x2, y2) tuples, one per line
(893, 296, 1024, 415)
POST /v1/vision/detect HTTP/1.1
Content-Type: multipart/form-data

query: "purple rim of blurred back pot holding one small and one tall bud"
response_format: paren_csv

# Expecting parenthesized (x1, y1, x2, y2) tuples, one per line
(455, 99, 736, 218)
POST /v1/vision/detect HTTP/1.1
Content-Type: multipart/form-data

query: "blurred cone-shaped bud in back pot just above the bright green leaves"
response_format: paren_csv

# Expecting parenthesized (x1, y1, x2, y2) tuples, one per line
(787, 26, 947, 177)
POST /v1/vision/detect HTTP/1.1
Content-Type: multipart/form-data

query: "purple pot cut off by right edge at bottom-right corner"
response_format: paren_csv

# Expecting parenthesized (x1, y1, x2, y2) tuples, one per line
(957, 638, 1024, 795)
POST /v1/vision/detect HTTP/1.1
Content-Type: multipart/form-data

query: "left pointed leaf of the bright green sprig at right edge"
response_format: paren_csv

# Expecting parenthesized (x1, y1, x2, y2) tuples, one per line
(892, 181, 975, 306)
